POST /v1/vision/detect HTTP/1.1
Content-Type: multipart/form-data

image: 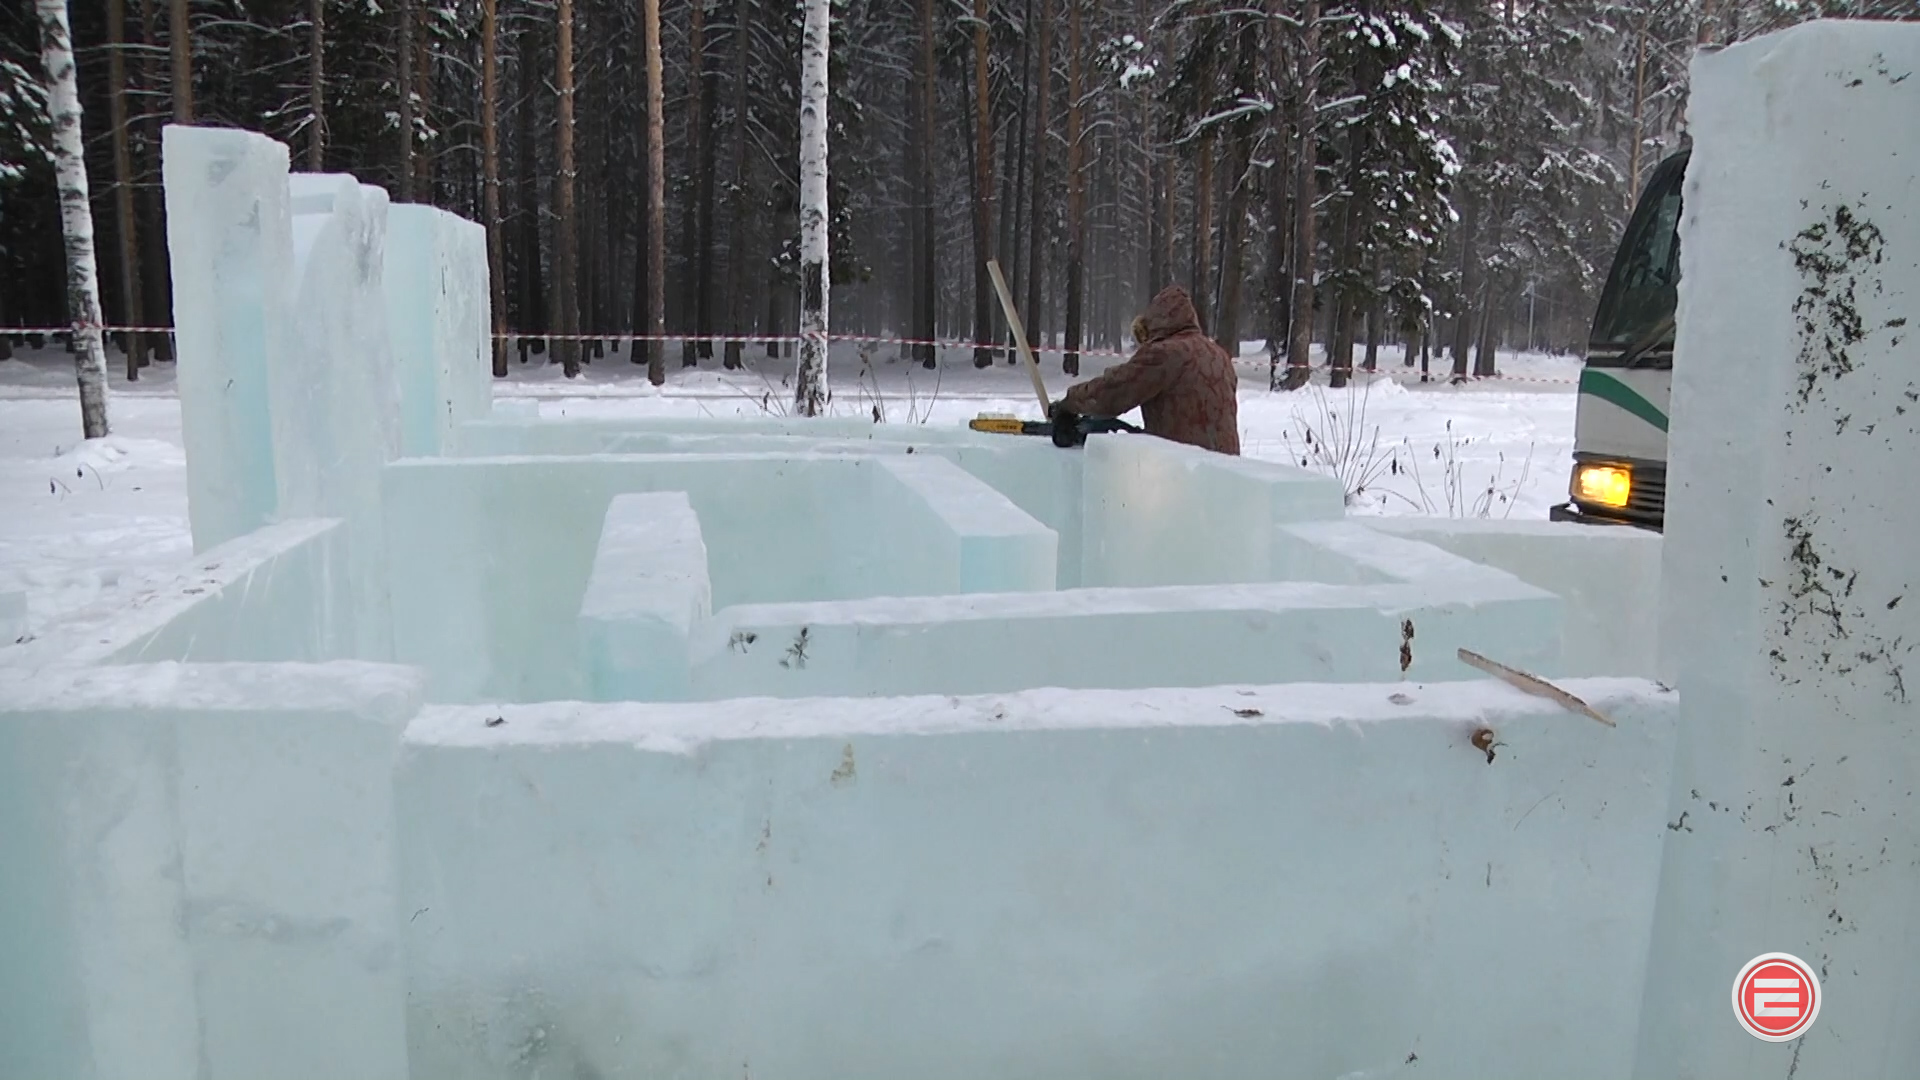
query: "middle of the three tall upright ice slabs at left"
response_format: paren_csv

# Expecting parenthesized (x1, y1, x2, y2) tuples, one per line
(273, 173, 399, 659)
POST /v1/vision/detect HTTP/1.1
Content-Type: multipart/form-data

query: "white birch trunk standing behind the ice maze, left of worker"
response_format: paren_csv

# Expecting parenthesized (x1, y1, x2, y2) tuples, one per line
(793, 0, 831, 417)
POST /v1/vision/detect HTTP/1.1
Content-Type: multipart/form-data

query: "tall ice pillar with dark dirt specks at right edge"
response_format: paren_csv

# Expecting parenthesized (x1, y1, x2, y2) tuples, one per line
(1636, 23, 1920, 1080)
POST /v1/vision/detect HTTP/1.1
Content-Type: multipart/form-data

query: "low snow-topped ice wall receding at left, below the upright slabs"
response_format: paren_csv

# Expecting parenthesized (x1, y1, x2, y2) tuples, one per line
(0, 519, 351, 669)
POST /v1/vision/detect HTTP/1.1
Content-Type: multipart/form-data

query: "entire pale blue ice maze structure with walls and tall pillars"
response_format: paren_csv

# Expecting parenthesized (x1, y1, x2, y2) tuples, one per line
(0, 25, 1920, 1080)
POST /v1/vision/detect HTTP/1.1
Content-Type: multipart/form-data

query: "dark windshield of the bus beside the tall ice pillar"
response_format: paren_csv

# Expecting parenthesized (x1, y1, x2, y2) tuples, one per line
(1592, 158, 1686, 348)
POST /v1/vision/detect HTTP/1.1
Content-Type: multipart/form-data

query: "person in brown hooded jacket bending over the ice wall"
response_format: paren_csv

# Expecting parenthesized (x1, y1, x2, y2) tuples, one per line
(1048, 284, 1240, 455)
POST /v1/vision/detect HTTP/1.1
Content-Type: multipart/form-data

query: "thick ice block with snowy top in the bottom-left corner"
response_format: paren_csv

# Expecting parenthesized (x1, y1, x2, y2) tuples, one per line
(0, 663, 420, 1080)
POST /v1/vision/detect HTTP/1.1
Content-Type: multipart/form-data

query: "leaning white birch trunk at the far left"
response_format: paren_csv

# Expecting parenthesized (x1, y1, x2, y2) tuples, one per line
(35, 0, 108, 438)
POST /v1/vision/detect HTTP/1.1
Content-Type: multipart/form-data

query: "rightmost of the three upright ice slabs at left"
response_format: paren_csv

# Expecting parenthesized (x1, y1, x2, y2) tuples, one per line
(384, 204, 493, 455)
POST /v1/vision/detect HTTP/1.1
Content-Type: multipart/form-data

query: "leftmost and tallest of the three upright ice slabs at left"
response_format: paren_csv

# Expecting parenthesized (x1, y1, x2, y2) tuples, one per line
(161, 125, 292, 552)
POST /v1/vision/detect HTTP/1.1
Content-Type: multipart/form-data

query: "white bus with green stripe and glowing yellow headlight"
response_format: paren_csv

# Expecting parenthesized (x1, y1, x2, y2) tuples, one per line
(1549, 150, 1688, 532)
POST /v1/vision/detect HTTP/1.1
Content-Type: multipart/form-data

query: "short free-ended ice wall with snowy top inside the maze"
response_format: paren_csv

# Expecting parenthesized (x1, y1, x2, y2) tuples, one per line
(580, 492, 712, 701)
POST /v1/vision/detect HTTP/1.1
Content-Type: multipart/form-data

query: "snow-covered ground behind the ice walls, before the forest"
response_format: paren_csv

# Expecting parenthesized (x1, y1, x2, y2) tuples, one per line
(0, 342, 1580, 626)
